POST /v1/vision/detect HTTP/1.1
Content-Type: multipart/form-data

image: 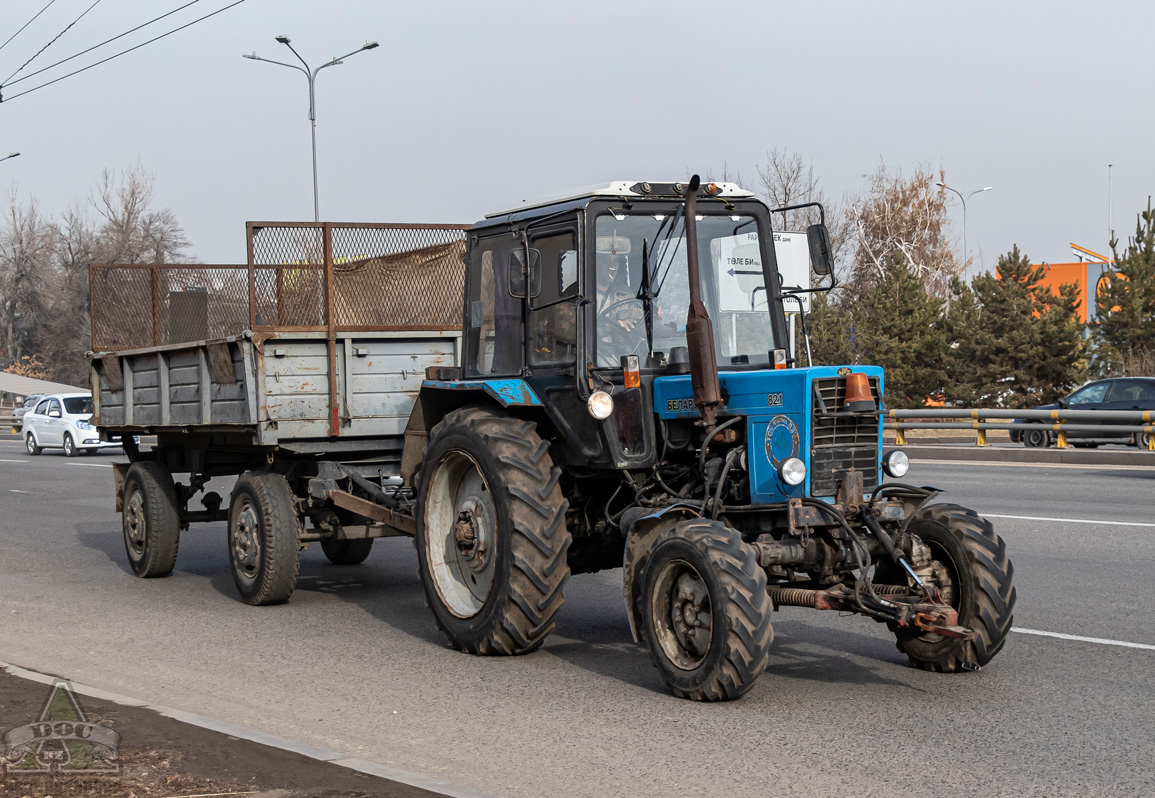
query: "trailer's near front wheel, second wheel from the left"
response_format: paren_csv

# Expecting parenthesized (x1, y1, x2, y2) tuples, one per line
(229, 471, 300, 606)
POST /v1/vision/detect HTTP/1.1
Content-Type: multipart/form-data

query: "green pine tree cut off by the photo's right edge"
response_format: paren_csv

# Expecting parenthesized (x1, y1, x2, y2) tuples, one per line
(1091, 197, 1155, 376)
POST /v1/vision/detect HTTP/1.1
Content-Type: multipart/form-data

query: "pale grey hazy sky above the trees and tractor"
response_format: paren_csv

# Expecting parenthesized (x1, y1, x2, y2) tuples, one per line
(0, 0, 1155, 271)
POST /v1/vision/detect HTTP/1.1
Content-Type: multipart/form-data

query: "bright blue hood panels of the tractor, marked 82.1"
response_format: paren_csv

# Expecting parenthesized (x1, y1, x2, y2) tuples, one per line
(654, 366, 882, 505)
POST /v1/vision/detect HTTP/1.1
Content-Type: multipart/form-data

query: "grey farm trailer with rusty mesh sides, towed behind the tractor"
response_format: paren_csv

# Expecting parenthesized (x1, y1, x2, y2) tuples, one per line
(90, 223, 465, 604)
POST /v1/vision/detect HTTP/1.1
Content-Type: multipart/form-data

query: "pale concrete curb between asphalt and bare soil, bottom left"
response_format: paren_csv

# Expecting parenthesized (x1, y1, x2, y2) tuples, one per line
(0, 661, 492, 798)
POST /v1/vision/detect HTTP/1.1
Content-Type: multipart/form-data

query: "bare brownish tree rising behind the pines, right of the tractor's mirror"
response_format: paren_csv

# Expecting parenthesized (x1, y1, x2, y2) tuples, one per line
(848, 163, 963, 297)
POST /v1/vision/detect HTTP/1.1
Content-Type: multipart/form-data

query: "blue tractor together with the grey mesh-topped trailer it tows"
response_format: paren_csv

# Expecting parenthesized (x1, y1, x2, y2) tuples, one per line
(91, 185, 1016, 701)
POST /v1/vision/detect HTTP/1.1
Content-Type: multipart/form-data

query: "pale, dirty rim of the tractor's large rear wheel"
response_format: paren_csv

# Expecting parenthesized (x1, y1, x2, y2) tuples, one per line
(423, 452, 498, 618)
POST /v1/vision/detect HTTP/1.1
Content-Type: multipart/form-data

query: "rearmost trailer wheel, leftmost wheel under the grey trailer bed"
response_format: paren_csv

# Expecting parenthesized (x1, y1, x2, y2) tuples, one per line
(120, 460, 180, 579)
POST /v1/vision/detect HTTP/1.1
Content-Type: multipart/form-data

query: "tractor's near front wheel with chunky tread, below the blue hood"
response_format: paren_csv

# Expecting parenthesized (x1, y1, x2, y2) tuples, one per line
(641, 519, 774, 701)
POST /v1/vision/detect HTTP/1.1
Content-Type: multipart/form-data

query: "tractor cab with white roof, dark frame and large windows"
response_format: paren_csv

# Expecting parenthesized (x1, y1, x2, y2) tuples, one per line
(436, 181, 817, 470)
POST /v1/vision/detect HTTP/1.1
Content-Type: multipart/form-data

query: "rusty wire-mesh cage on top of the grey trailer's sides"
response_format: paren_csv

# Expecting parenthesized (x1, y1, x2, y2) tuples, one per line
(89, 222, 469, 352)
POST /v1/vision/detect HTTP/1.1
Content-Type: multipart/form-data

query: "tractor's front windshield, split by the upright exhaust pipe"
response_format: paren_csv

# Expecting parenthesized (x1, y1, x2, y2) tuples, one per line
(591, 209, 782, 367)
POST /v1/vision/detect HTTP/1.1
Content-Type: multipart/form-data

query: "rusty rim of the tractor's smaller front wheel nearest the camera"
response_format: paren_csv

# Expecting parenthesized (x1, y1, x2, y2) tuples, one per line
(650, 560, 714, 671)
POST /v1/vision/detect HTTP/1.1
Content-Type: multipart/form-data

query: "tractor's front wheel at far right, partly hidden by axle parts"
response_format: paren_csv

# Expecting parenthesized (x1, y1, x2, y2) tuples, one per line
(892, 505, 1016, 673)
